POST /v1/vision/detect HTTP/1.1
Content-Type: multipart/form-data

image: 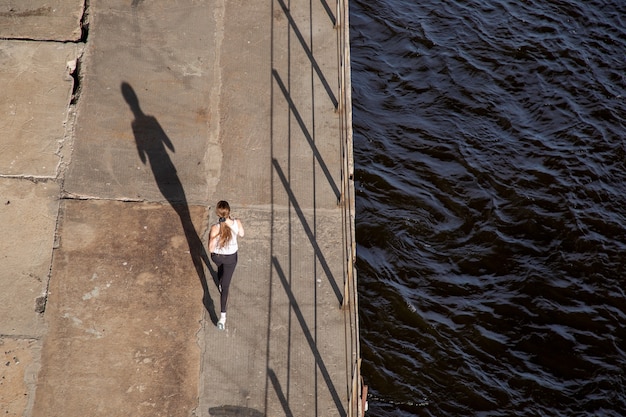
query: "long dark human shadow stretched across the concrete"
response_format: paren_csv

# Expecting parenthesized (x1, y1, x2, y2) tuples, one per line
(121, 82, 217, 324)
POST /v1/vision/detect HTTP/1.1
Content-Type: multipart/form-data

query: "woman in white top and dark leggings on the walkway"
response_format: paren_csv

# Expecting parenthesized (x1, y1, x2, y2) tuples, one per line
(209, 201, 244, 330)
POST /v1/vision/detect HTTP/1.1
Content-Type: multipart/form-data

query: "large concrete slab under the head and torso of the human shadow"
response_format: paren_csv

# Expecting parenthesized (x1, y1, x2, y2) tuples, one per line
(65, 0, 221, 202)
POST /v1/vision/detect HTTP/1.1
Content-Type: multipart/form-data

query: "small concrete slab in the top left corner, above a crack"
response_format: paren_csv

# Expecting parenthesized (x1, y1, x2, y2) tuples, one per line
(0, 0, 85, 41)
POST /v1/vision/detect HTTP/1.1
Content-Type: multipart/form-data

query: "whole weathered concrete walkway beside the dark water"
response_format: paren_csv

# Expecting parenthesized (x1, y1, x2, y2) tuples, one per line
(0, 0, 353, 417)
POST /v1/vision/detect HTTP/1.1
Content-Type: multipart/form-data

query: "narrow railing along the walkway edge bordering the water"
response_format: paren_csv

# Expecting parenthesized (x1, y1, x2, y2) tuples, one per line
(335, 0, 367, 417)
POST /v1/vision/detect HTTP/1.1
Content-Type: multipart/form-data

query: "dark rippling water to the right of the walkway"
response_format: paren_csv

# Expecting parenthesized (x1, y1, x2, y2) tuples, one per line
(350, 0, 626, 416)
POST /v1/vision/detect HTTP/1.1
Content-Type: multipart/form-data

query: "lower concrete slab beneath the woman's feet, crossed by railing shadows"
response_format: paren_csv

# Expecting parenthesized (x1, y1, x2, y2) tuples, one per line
(200, 208, 347, 416)
